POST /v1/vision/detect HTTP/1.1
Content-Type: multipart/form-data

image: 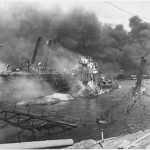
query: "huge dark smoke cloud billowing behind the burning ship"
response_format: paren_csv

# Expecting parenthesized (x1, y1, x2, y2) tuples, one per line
(0, 2, 150, 75)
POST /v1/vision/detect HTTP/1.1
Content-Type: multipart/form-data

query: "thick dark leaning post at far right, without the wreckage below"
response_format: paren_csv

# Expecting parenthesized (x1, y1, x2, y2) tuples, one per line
(136, 57, 146, 89)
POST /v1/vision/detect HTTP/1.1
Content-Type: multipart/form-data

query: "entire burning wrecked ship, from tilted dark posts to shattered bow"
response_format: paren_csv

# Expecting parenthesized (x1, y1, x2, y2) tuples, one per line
(0, 37, 119, 97)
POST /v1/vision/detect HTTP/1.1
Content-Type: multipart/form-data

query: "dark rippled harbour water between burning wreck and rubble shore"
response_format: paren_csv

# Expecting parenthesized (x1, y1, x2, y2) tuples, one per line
(0, 80, 150, 143)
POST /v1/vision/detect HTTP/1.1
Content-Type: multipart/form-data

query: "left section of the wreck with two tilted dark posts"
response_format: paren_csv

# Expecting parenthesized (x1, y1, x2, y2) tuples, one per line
(0, 37, 70, 92)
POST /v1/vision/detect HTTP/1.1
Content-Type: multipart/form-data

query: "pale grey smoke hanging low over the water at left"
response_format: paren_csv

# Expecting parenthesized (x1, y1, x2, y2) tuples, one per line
(0, 78, 55, 102)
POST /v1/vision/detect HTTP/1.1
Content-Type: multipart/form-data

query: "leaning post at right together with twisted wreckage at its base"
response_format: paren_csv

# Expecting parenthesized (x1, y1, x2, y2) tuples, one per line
(100, 57, 146, 131)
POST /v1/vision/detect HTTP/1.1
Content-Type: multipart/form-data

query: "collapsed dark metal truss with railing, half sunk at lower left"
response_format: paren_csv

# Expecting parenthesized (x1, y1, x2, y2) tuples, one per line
(0, 101, 80, 139)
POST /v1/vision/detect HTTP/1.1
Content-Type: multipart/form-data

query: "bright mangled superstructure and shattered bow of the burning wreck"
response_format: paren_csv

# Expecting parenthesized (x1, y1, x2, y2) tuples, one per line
(71, 56, 119, 97)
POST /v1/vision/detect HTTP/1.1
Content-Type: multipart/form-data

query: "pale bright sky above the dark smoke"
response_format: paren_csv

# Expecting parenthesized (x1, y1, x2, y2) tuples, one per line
(0, 0, 150, 31)
